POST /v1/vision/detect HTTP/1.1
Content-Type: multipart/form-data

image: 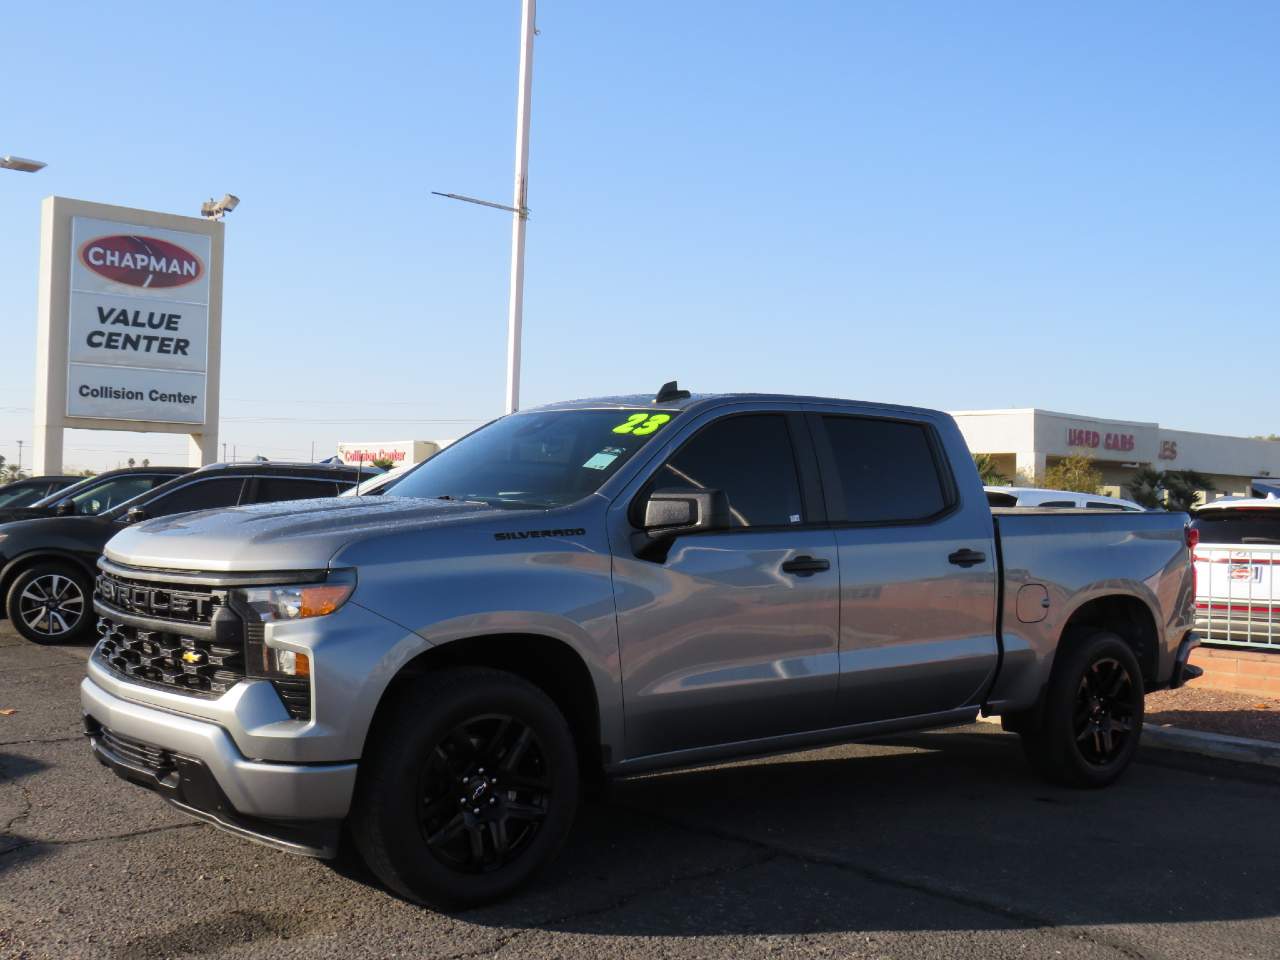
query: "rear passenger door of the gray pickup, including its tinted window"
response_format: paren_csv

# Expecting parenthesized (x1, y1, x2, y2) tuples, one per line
(809, 410, 998, 723)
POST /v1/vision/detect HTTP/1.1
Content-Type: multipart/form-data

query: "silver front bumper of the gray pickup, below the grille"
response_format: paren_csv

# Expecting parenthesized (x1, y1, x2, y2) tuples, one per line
(81, 677, 356, 856)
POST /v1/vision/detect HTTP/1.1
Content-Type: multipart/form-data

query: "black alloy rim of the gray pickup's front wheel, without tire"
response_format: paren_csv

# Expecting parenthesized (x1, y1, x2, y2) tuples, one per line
(419, 714, 552, 873)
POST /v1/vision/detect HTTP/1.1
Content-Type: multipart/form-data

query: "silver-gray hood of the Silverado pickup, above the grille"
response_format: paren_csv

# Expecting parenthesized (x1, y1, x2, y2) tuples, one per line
(105, 495, 497, 572)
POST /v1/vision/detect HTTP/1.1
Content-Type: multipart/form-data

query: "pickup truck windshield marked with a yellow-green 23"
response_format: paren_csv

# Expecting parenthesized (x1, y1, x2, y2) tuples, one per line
(387, 410, 678, 509)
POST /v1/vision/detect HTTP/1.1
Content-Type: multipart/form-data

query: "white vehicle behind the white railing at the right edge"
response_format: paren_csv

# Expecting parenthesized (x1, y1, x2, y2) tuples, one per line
(1192, 494, 1280, 650)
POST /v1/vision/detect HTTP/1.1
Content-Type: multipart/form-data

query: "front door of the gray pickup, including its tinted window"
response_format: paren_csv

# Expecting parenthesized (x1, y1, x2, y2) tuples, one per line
(611, 410, 838, 759)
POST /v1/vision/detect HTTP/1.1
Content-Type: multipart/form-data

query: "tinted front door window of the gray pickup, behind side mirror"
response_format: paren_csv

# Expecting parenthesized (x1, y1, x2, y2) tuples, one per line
(648, 413, 803, 527)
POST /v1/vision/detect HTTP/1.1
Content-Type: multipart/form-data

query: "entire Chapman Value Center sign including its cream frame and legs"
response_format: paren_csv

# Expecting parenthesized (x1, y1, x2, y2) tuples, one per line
(33, 197, 225, 474)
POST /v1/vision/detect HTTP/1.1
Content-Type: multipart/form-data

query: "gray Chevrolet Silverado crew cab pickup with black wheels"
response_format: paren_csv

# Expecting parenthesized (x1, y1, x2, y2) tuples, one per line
(81, 384, 1196, 906)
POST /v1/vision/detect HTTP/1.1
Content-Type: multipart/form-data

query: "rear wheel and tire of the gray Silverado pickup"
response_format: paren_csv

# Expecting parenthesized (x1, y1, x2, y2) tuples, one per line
(1021, 631, 1146, 787)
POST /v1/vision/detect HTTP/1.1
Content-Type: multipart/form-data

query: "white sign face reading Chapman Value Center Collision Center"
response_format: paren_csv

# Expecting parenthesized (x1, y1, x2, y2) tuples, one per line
(67, 216, 212, 425)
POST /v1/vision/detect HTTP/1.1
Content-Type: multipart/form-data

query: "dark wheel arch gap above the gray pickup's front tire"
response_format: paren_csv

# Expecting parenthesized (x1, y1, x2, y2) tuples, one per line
(366, 632, 608, 778)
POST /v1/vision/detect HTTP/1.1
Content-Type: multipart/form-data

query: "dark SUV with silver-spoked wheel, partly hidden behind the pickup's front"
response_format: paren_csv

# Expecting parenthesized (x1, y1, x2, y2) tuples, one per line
(0, 462, 360, 644)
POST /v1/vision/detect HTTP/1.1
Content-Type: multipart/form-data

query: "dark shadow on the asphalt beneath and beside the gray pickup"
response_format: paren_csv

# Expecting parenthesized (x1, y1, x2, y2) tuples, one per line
(442, 732, 1280, 936)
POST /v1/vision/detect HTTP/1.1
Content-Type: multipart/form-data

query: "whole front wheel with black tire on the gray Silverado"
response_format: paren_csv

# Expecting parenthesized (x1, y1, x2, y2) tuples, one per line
(349, 667, 579, 909)
